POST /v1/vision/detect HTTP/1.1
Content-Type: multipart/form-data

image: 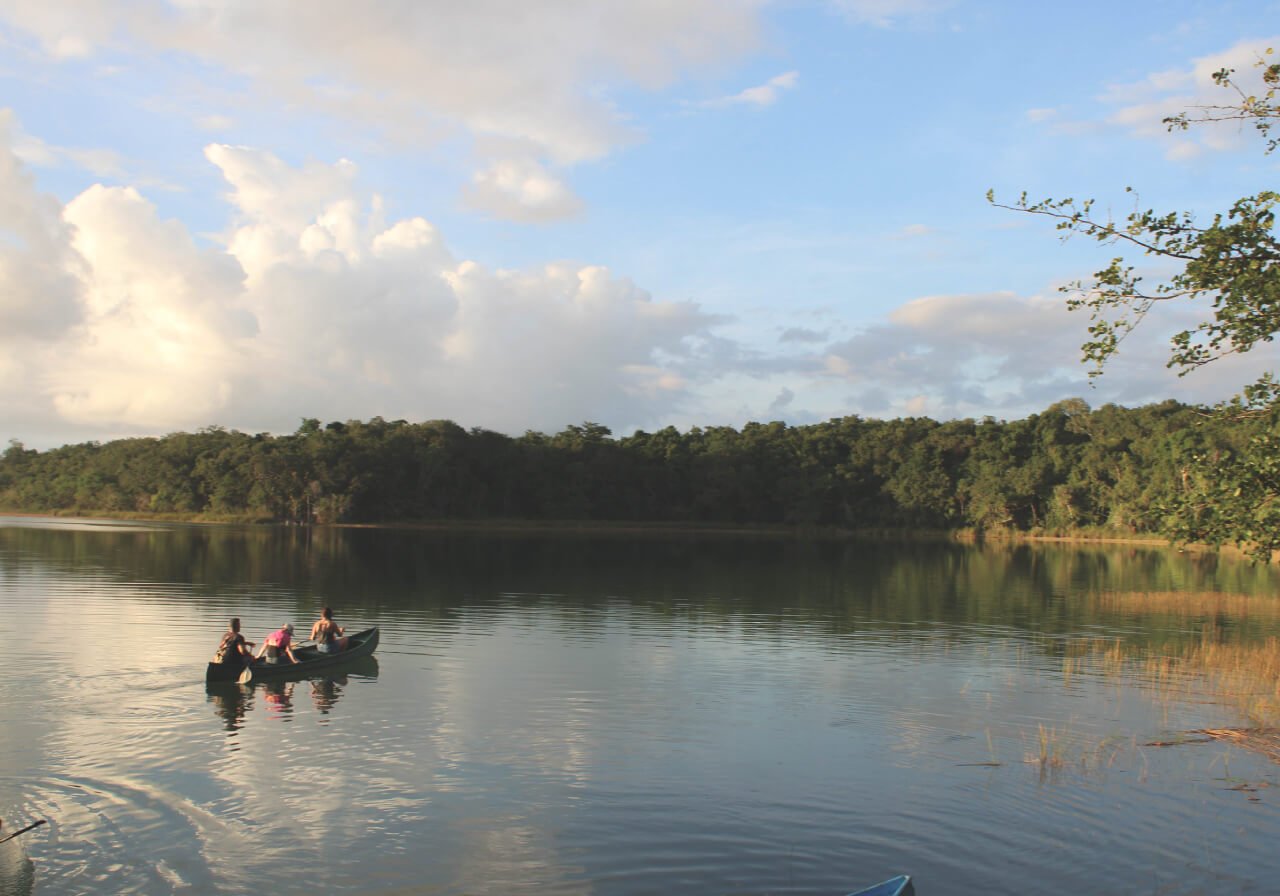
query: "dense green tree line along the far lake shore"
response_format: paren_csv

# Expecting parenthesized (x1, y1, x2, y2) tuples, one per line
(0, 399, 1262, 542)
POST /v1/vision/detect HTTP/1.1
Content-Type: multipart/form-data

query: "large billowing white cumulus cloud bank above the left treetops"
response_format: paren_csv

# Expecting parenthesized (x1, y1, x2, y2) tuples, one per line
(0, 119, 716, 438)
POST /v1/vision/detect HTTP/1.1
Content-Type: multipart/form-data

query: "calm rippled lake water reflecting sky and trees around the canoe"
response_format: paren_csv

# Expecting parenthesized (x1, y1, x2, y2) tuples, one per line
(0, 518, 1280, 896)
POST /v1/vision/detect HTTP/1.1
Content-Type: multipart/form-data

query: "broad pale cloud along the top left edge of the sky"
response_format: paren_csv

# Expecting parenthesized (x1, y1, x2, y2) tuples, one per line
(0, 0, 762, 219)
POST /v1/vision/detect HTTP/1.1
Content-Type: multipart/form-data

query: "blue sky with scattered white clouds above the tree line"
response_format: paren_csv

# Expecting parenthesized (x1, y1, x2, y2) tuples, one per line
(0, 0, 1280, 449)
